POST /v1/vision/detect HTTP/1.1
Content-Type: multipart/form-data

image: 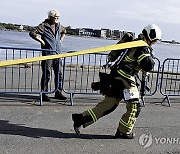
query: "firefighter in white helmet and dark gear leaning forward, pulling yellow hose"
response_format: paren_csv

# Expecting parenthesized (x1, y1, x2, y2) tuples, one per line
(72, 24, 162, 139)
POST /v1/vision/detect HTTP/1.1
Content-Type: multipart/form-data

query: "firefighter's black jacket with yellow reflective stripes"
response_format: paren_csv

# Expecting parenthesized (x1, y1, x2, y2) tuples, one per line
(109, 33, 155, 82)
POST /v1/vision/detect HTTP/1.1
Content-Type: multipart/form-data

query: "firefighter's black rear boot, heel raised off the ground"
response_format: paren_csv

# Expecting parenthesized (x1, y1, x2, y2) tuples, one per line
(72, 114, 83, 135)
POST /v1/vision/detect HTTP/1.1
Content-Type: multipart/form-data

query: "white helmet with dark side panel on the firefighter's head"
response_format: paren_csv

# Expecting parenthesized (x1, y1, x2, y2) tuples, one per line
(142, 24, 162, 41)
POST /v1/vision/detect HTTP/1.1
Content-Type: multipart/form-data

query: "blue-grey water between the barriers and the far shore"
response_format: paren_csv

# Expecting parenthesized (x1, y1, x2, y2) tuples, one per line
(0, 31, 180, 62)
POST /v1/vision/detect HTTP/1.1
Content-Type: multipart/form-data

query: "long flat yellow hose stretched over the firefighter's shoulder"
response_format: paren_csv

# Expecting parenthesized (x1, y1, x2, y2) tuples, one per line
(0, 40, 148, 67)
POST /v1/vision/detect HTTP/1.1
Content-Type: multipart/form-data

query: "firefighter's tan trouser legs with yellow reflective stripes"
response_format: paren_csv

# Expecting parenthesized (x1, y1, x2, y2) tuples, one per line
(82, 96, 140, 134)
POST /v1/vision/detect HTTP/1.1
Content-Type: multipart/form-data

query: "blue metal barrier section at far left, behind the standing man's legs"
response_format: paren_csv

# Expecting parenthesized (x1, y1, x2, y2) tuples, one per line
(0, 47, 60, 105)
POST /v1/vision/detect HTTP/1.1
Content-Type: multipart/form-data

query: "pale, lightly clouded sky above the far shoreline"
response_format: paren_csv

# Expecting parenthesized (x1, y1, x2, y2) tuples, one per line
(0, 0, 180, 42)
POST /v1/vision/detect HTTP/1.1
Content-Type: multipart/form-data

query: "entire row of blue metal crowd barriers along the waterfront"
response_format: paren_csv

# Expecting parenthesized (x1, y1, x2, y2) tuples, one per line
(0, 47, 180, 106)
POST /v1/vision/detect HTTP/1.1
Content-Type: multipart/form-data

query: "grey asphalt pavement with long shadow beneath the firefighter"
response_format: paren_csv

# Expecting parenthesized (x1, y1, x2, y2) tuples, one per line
(0, 94, 180, 154)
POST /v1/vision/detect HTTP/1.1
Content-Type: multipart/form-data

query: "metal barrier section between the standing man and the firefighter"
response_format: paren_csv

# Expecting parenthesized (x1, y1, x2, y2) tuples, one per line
(63, 53, 109, 105)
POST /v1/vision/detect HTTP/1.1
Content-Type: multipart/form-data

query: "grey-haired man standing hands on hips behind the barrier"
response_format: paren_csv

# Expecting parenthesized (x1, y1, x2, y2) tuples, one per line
(29, 10, 67, 101)
